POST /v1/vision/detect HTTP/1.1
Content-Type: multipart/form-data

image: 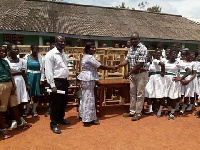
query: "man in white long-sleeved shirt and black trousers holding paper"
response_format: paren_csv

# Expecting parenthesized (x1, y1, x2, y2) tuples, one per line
(45, 36, 70, 134)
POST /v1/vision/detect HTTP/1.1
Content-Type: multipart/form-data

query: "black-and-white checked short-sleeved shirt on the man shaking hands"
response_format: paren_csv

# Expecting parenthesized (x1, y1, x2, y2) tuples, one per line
(125, 43, 148, 70)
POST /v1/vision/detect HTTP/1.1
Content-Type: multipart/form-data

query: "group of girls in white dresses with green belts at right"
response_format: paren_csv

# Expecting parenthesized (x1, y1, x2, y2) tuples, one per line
(145, 48, 200, 119)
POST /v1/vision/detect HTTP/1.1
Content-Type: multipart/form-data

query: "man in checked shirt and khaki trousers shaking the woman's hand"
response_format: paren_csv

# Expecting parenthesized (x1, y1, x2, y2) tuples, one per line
(118, 32, 148, 121)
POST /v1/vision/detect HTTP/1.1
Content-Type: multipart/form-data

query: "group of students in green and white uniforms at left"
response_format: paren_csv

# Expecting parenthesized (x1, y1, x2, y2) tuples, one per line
(0, 44, 44, 139)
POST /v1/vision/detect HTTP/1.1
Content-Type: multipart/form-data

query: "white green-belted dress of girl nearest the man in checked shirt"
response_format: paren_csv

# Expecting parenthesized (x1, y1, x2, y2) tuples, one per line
(145, 59, 165, 98)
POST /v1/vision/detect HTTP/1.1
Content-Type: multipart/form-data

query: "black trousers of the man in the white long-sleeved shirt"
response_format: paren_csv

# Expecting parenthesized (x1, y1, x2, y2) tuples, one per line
(50, 78, 69, 125)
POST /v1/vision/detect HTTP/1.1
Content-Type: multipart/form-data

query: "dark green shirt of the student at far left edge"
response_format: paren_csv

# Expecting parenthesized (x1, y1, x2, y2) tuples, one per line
(0, 59, 11, 82)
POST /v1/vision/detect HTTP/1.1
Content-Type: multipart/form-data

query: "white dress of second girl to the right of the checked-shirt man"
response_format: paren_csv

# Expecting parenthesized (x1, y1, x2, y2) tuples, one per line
(165, 60, 185, 99)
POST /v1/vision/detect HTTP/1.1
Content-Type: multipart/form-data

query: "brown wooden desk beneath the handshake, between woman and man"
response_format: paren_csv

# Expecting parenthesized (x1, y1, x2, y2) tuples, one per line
(97, 79, 130, 117)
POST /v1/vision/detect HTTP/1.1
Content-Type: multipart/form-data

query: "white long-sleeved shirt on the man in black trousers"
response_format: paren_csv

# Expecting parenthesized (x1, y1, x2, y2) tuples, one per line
(45, 47, 69, 88)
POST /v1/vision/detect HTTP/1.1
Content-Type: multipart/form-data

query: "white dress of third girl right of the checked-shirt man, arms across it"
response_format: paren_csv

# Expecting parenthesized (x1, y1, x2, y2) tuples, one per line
(180, 60, 197, 97)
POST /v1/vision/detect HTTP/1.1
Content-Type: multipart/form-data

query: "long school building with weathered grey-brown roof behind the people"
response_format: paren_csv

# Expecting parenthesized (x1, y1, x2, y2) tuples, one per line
(0, 0, 200, 50)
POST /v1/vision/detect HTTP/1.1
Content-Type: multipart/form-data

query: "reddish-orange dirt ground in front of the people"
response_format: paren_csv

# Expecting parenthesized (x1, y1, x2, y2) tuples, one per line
(0, 105, 200, 150)
